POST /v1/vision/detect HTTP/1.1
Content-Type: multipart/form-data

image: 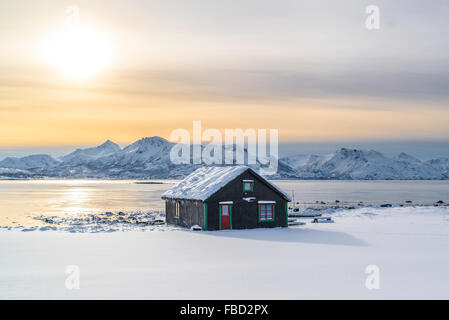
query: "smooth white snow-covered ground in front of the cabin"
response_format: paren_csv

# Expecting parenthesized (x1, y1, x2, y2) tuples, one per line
(0, 207, 449, 299)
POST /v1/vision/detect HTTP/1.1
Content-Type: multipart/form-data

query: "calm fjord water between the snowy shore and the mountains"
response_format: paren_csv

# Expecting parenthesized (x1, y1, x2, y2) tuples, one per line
(0, 180, 449, 226)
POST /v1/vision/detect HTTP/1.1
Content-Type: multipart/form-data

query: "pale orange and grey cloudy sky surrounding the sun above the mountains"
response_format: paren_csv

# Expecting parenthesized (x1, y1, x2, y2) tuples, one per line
(0, 0, 449, 148)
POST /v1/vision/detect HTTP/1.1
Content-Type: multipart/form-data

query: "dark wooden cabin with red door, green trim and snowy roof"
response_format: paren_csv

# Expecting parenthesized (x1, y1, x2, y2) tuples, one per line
(162, 166, 291, 230)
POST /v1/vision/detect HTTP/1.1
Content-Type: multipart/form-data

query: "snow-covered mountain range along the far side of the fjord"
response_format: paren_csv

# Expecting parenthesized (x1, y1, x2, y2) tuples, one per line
(0, 140, 449, 180)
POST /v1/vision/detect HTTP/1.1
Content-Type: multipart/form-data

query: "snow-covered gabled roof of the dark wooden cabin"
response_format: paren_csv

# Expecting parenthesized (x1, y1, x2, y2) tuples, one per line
(162, 166, 291, 201)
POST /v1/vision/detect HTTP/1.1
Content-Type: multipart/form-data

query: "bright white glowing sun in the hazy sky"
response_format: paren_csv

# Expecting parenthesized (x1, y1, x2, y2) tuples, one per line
(47, 27, 112, 79)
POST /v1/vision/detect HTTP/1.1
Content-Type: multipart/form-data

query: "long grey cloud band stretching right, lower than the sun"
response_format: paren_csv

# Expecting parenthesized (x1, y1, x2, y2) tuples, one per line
(107, 69, 449, 108)
